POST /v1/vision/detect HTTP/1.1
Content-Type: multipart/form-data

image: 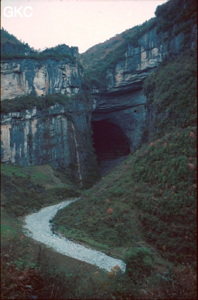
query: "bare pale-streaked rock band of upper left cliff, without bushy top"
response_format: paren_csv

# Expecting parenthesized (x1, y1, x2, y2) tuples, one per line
(1, 59, 81, 100)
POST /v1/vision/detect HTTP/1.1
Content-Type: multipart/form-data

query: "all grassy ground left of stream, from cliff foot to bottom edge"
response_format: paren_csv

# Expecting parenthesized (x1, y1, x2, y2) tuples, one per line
(1, 164, 89, 299)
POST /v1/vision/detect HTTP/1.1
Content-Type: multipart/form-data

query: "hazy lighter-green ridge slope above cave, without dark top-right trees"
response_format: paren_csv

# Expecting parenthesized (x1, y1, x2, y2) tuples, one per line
(80, 18, 156, 89)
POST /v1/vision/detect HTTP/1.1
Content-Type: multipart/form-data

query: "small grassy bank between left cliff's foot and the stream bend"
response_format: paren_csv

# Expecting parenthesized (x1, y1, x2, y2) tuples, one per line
(1, 164, 79, 216)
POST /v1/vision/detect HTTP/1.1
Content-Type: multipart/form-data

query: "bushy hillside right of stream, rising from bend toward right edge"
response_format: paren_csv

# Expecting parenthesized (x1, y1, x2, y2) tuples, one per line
(55, 127, 196, 262)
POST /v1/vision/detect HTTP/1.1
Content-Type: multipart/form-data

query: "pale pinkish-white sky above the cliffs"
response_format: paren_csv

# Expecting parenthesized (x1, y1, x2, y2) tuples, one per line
(1, 0, 167, 53)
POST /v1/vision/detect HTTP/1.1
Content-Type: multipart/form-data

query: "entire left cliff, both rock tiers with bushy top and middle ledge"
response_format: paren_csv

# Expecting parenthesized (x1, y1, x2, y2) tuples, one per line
(1, 33, 97, 184)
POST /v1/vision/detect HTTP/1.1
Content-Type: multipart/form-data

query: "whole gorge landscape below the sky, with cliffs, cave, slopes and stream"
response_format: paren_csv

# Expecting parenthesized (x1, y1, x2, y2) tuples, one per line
(1, 0, 197, 300)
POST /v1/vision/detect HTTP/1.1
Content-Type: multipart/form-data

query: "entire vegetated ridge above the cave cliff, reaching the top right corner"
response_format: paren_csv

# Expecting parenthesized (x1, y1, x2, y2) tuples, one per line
(81, 0, 197, 89)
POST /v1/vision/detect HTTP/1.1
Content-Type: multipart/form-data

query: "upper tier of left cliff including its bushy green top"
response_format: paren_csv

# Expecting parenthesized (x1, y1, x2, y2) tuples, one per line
(1, 29, 81, 100)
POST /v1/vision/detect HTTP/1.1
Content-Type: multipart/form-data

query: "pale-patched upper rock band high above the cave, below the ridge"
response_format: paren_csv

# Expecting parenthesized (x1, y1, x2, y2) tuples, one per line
(106, 28, 162, 92)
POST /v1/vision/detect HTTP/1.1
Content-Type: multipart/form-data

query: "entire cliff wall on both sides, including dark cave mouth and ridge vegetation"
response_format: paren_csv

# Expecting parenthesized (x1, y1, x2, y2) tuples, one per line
(1, 1, 196, 182)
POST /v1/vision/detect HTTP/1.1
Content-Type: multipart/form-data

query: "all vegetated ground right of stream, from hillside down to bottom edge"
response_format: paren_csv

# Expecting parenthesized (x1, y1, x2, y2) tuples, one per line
(54, 127, 196, 299)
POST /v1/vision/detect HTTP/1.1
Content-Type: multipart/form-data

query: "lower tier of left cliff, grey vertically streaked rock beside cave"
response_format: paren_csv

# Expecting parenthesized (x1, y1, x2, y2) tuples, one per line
(1, 103, 97, 183)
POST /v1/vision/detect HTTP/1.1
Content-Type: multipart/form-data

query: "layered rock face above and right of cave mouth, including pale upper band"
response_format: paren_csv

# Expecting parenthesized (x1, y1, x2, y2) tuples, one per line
(92, 21, 196, 152)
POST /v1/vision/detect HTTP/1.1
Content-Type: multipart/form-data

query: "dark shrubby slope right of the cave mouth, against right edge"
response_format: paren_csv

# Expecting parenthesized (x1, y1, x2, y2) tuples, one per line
(144, 50, 197, 139)
